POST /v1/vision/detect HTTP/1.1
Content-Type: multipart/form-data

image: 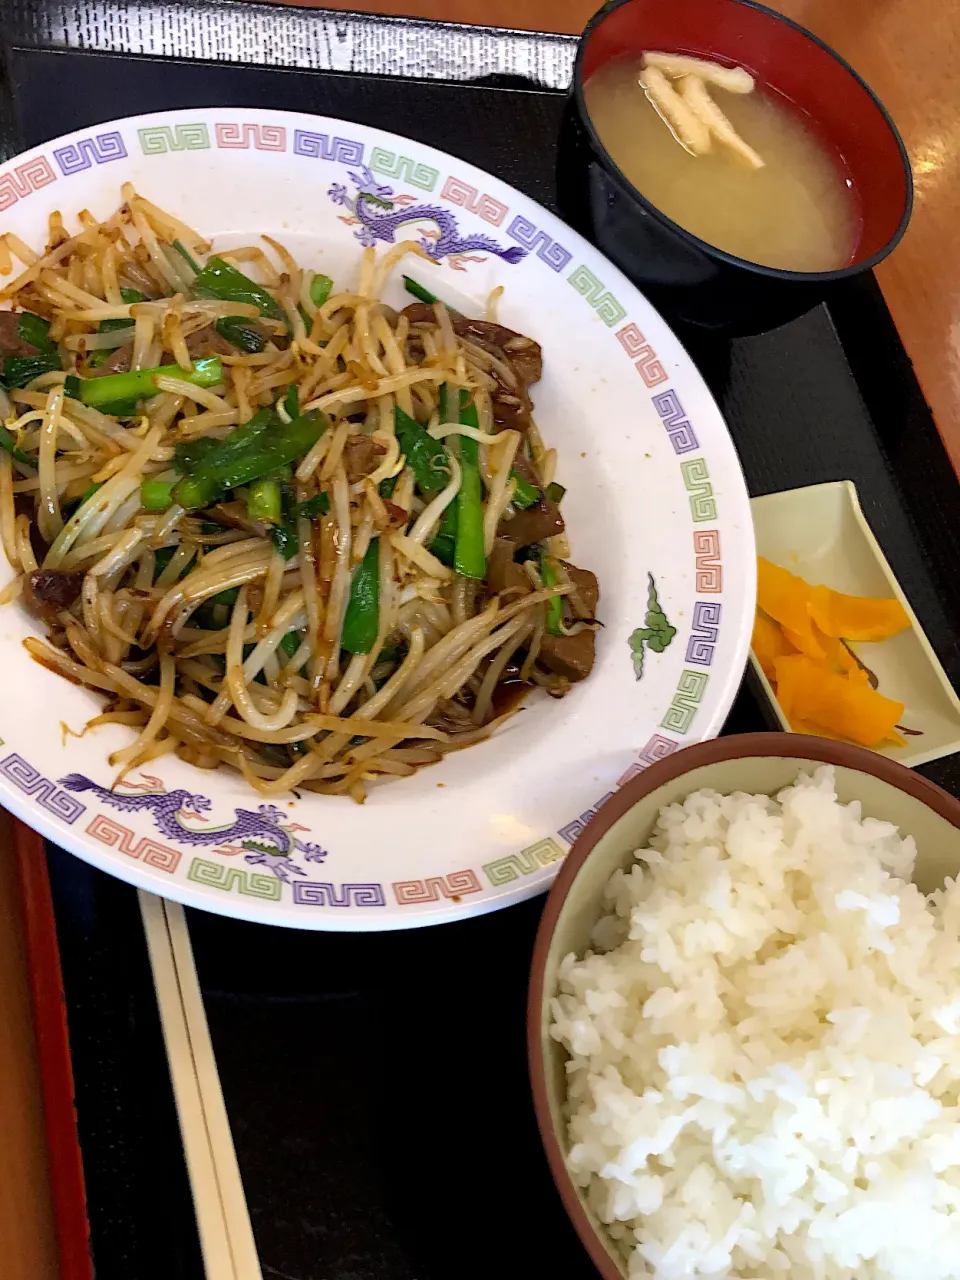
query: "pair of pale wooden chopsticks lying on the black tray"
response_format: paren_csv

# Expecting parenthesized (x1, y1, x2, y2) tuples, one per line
(140, 891, 262, 1280)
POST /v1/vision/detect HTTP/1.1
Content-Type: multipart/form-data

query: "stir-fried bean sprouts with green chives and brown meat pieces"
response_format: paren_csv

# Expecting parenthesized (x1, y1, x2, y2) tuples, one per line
(0, 184, 599, 801)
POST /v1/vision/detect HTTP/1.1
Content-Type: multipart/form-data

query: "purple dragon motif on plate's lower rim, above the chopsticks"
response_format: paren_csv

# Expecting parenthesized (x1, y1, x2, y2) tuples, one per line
(60, 773, 326, 883)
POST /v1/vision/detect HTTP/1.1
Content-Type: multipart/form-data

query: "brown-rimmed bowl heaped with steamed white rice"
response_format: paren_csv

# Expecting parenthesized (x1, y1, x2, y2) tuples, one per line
(527, 733, 960, 1280)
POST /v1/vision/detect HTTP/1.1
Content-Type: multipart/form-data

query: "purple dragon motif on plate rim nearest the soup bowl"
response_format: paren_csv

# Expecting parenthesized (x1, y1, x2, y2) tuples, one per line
(328, 165, 526, 270)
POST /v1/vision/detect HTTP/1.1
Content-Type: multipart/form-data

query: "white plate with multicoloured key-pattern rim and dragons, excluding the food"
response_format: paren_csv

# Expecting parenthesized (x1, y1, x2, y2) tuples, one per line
(0, 109, 755, 931)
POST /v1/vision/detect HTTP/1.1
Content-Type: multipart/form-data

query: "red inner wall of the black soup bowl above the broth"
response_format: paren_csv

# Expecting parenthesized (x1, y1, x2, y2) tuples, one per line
(580, 0, 911, 266)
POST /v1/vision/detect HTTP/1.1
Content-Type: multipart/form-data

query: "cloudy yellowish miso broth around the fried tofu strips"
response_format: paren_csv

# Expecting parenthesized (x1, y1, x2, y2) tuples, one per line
(584, 55, 859, 271)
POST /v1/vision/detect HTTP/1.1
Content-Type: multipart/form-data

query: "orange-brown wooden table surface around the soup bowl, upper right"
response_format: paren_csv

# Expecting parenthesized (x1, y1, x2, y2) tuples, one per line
(272, 0, 960, 472)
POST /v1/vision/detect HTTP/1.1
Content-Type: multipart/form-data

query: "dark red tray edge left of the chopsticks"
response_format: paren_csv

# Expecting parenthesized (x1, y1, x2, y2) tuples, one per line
(13, 819, 93, 1280)
